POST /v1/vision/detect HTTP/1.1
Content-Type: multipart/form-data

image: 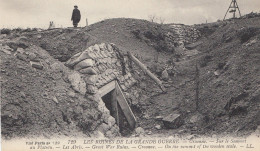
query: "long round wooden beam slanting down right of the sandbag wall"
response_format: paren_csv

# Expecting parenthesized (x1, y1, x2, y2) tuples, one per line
(127, 51, 166, 92)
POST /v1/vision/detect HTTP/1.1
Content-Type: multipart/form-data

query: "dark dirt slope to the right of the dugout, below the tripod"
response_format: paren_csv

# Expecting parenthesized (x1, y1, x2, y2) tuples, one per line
(136, 17, 260, 136)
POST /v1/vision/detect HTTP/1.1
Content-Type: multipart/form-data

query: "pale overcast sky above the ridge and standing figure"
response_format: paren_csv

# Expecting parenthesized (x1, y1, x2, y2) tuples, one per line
(0, 0, 260, 28)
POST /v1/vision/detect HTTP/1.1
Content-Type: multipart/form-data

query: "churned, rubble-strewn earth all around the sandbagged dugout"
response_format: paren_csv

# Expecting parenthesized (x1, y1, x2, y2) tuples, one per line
(0, 16, 260, 138)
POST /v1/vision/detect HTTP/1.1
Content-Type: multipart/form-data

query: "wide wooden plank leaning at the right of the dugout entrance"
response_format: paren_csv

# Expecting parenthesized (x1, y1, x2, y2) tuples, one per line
(115, 82, 136, 129)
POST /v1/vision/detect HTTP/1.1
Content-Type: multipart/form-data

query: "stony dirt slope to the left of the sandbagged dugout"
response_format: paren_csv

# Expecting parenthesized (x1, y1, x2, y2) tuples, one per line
(0, 39, 100, 138)
